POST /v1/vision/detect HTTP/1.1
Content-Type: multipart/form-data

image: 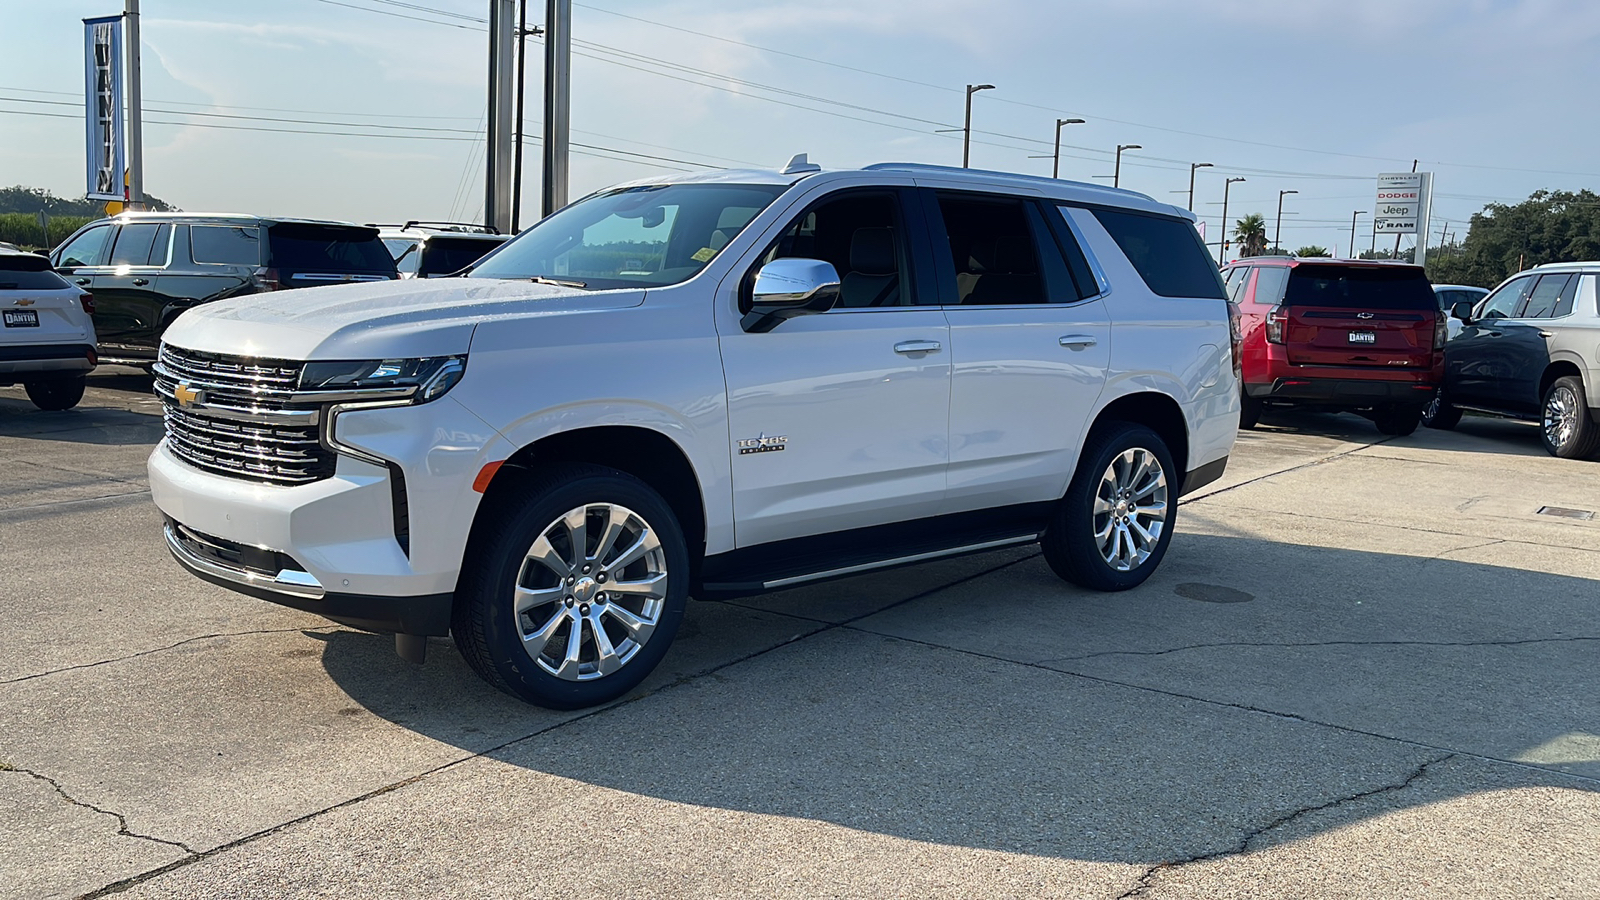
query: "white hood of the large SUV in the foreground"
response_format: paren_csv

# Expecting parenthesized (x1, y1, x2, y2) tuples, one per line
(162, 279, 645, 360)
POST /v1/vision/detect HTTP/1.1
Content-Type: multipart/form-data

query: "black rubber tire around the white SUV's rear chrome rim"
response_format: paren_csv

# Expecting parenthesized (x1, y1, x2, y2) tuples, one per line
(1038, 421, 1182, 591)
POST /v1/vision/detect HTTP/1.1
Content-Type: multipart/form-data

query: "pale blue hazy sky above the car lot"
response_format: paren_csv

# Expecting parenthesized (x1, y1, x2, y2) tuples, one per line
(0, 0, 1600, 253)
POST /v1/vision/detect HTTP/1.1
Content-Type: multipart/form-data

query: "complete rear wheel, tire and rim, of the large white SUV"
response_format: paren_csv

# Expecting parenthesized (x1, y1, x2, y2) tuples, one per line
(1038, 423, 1178, 591)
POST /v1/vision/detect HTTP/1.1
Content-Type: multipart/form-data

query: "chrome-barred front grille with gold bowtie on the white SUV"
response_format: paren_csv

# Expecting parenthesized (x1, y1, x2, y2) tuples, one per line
(155, 344, 334, 485)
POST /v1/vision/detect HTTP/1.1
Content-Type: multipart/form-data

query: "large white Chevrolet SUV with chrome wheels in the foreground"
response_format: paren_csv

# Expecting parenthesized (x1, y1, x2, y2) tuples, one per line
(150, 157, 1238, 708)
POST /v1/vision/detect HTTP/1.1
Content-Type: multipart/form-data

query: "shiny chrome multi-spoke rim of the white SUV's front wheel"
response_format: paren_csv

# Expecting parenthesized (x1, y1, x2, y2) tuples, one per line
(512, 503, 667, 681)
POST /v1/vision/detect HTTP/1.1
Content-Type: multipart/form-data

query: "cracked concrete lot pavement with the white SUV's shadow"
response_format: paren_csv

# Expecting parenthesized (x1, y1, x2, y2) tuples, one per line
(0, 376, 1600, 898)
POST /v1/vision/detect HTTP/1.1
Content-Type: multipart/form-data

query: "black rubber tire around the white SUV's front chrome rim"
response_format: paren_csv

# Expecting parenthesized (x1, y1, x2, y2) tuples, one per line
(451, 464, 690, 709)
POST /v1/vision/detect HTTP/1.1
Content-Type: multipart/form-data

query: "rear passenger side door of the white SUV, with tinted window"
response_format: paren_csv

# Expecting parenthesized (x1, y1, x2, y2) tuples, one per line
(918, 191, 1110, 512)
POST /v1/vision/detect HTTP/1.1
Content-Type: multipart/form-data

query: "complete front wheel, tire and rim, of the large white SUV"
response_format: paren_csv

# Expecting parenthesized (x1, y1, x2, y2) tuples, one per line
(451, 464, 690, 709)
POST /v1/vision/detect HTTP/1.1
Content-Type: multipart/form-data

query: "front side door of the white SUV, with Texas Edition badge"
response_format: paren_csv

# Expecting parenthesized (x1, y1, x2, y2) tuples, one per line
(718, 189, 950, 548)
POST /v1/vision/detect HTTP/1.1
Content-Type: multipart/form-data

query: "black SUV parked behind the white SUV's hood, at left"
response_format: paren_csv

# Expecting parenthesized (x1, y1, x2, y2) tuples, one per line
(50, 213, 400, 367)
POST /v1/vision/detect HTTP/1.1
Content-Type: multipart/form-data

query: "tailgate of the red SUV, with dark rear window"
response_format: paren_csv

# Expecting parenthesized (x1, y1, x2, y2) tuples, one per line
(1283, 264, 1438, 370)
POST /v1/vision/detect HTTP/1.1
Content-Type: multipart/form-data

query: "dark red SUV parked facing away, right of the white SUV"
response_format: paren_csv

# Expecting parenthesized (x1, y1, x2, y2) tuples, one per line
(1222, 256, 1448, 434)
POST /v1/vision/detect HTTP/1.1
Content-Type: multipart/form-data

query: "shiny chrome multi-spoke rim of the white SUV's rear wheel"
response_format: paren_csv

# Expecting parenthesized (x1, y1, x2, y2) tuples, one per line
(1093, 447, 1166, 572)
